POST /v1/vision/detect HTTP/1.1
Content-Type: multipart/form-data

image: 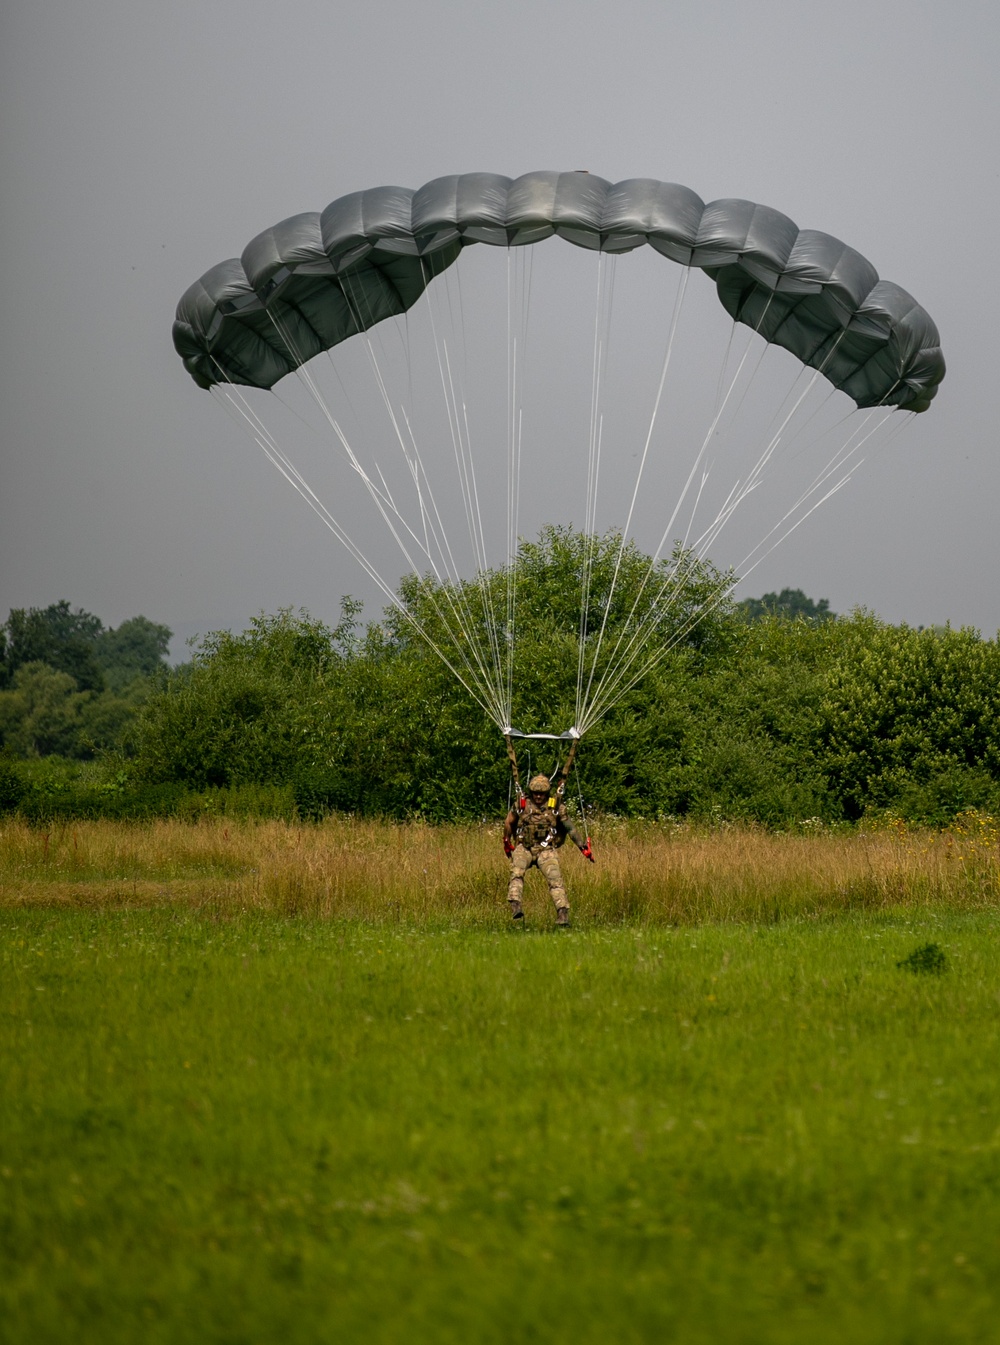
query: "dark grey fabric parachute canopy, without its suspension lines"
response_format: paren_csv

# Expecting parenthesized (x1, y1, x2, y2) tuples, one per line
(174, 172, 945, 412)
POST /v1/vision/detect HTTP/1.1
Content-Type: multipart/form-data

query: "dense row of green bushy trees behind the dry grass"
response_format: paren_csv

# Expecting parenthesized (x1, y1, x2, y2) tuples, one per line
(0, 531, 1000, 826)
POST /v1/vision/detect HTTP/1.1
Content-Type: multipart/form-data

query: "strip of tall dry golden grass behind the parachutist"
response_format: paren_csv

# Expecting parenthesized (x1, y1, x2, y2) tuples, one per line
(0, 814, 1000, 924)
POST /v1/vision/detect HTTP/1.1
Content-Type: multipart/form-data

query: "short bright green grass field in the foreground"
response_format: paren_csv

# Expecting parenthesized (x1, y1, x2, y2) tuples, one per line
(0, 908, 1000, 1345)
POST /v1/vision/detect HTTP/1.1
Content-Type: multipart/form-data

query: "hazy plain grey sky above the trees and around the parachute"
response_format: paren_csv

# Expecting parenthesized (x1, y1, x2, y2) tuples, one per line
(0, 0, 1000, 658)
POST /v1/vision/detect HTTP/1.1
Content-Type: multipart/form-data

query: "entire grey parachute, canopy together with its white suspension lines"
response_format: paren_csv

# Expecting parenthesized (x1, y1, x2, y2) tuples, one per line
(174, 172, 945, 738)
